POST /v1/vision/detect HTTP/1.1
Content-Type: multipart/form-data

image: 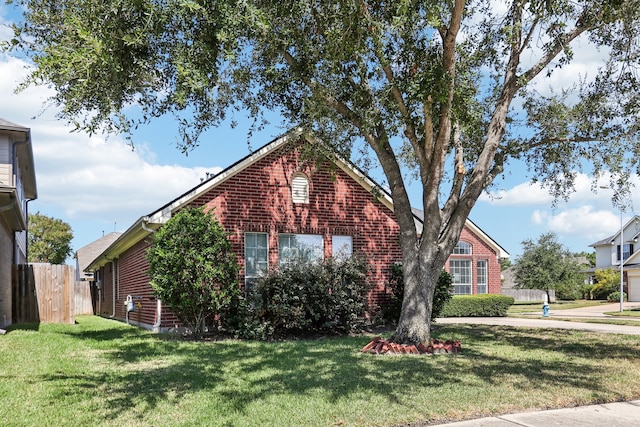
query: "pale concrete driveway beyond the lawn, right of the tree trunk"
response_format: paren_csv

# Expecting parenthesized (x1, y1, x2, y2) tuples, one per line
(436, 302, 640, 335)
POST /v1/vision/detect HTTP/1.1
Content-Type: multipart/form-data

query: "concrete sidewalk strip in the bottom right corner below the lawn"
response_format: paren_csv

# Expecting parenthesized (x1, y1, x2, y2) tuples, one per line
(438, 400, 640, 427)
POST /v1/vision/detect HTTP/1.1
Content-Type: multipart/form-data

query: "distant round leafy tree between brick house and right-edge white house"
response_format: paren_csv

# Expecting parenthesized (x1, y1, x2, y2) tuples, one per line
(513, 233, 584, 301)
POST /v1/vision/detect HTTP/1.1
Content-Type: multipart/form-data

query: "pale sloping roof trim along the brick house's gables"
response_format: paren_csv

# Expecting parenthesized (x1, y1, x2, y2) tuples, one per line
(86, 128, 509, 270)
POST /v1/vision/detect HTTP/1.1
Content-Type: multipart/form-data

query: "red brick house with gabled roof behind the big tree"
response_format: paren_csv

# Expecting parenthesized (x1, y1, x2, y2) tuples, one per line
(87, 132, 508, 330)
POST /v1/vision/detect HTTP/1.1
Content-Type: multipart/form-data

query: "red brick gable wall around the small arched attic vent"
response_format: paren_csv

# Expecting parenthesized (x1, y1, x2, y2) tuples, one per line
(192, 146, 402, 308)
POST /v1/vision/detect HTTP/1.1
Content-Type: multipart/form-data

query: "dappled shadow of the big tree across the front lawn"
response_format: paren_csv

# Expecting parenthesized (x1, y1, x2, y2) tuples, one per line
(37, 325, 640, 419)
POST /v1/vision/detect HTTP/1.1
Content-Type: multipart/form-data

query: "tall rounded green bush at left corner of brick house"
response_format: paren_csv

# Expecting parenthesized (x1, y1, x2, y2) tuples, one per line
(147, 208, 240, 338)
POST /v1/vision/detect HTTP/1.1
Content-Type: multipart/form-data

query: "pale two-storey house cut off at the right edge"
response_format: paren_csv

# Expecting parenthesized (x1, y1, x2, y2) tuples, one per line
(589, 215, 640, 301)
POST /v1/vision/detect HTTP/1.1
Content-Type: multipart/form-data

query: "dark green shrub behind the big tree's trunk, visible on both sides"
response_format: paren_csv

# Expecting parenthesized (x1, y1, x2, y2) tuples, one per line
(381, 264, 453, 323)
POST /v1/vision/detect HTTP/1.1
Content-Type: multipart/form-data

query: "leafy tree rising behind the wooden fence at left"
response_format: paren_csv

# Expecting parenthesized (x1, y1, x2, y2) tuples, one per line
(28, 212, 73, 264)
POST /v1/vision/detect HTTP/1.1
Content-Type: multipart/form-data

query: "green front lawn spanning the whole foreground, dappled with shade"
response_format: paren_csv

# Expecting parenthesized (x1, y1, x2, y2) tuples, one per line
(0, 316, 640, 426)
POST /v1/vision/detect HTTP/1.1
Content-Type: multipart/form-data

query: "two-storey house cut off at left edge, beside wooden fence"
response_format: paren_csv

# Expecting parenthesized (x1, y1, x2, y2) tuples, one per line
(0, 119, 38, 327)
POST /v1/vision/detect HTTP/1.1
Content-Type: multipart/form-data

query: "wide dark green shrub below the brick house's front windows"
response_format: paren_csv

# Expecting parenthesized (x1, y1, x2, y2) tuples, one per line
(227, 256, 371, 339)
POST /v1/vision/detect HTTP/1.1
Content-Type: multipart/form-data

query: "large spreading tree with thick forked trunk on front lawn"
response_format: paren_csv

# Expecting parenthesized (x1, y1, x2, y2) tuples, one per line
(9, 0, 640, 342)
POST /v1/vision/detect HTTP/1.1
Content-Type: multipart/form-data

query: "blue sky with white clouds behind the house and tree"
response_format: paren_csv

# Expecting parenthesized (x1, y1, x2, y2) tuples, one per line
(0, 3, 640, 260)
